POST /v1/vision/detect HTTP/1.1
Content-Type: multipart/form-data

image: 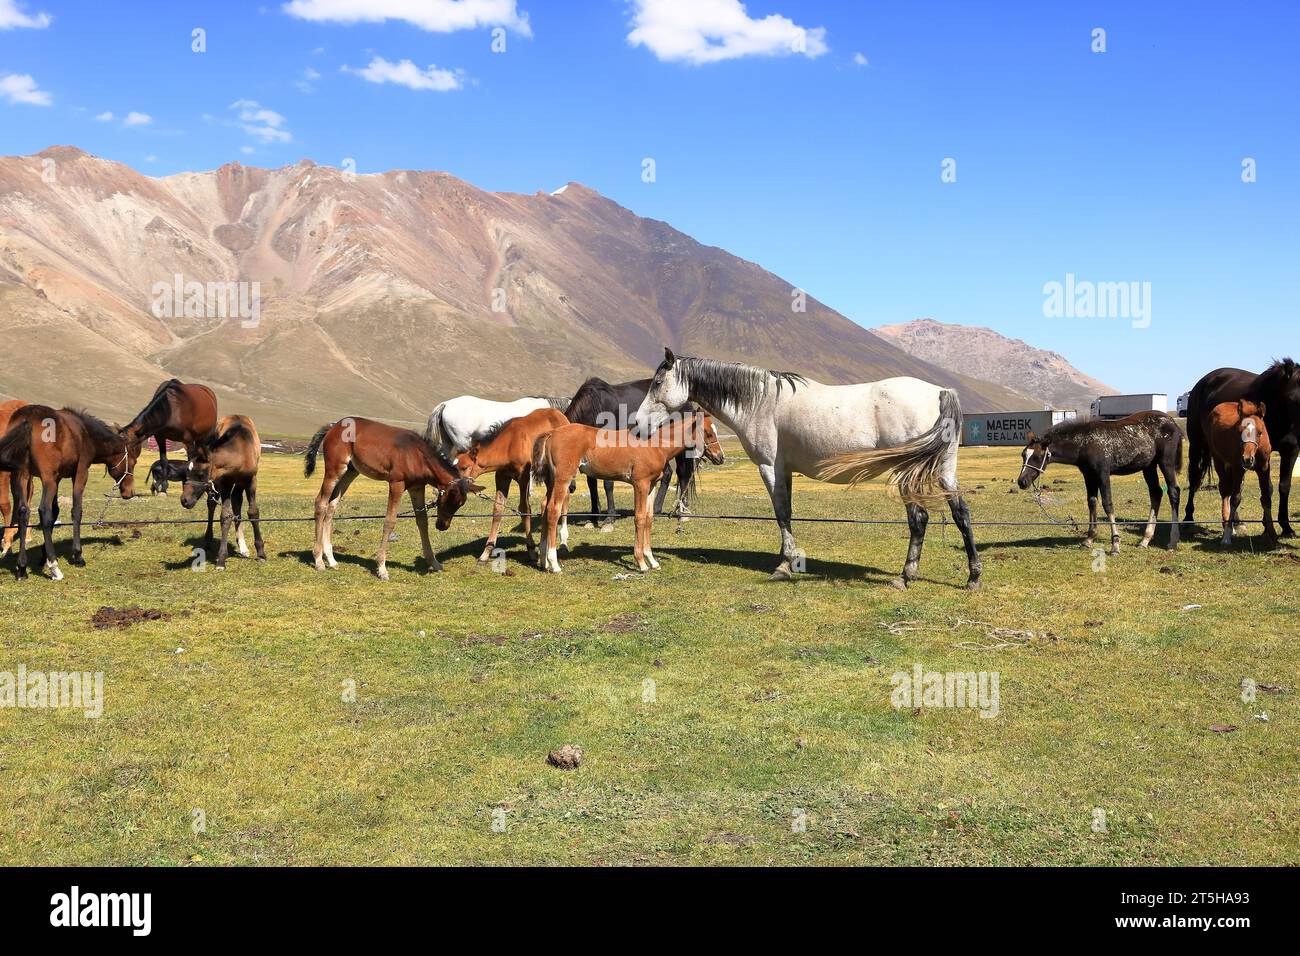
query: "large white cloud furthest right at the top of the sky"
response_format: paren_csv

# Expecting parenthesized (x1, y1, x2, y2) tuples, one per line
(628, 0, 829, 65)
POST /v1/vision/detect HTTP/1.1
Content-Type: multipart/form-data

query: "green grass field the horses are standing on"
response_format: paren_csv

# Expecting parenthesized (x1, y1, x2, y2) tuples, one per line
(0, 446, 1300, 866)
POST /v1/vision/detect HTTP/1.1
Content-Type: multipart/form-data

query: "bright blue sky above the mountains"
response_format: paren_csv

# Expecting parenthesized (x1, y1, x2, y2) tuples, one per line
(0, 0, 1300, 401)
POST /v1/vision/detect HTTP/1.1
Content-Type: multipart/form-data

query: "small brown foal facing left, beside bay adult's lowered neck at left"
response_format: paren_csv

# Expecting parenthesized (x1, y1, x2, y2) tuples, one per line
(179, 415, 267, 571)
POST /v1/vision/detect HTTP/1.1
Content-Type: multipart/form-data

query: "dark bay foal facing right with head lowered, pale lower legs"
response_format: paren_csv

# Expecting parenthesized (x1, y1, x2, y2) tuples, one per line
(303, 418, 482, 581)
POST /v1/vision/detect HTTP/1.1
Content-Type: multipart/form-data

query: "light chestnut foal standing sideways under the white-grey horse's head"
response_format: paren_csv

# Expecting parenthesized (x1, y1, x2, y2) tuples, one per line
(533, 411, 723, 574)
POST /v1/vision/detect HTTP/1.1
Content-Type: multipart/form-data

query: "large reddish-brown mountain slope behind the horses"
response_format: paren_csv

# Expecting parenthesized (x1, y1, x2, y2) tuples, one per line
(0, 147, 1032, 433)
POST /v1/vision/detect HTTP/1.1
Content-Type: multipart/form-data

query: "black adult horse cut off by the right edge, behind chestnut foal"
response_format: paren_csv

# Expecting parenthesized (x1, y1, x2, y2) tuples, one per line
(1183, 359, 1300, 537)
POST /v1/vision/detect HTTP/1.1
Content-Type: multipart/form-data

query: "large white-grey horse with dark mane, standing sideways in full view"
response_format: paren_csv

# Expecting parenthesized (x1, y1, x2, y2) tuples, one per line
(636, 349, 983, 589)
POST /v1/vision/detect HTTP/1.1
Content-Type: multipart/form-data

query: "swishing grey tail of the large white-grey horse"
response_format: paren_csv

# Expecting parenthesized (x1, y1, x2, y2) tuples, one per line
(818, 389, 962, 505)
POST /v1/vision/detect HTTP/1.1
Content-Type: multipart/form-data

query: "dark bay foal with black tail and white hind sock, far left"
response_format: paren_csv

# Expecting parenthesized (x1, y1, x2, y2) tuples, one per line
(0, 405, 140, 581)
